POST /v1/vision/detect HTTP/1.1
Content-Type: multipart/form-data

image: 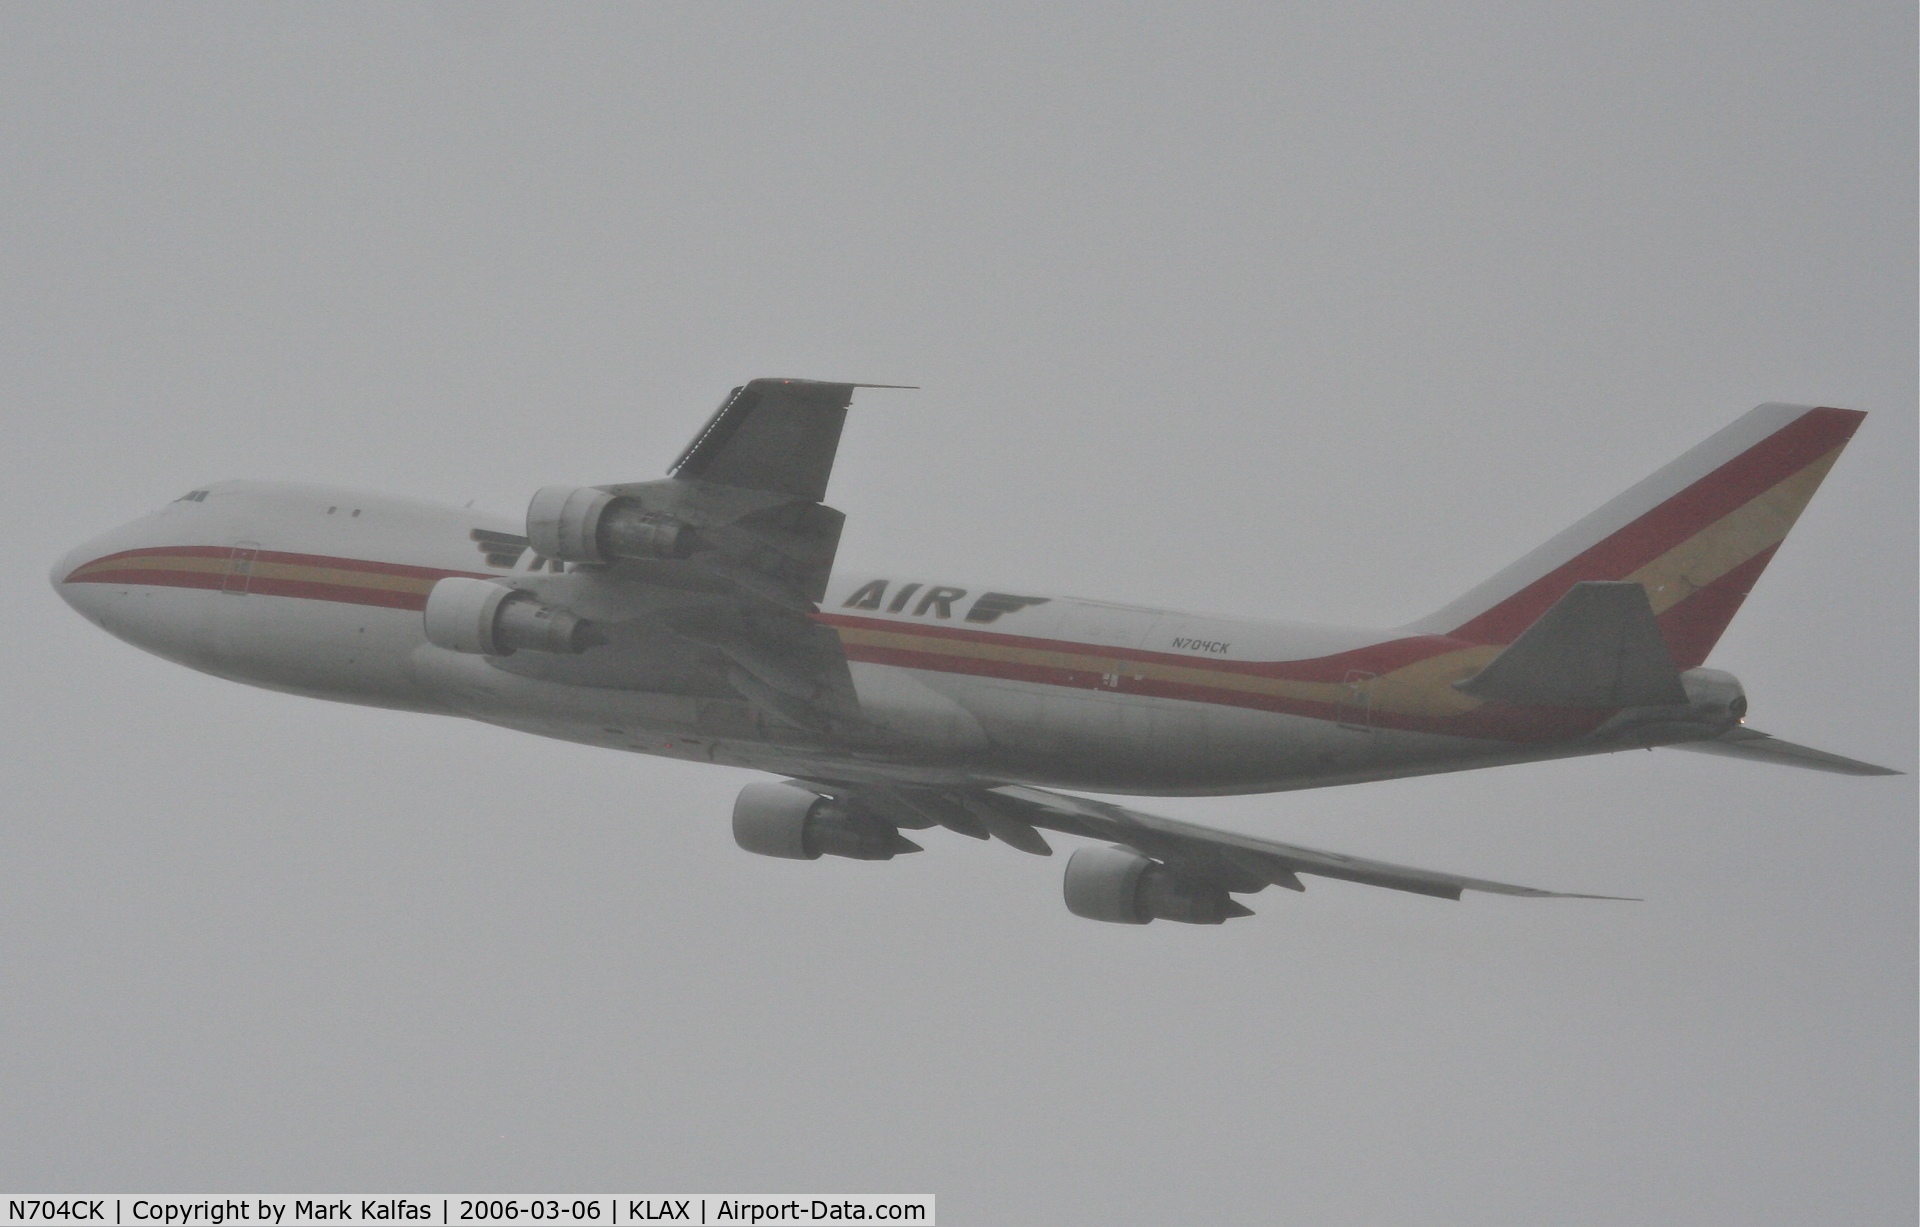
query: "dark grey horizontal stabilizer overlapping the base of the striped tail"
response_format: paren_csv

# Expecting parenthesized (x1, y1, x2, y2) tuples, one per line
(1455, 580, 1686, 707)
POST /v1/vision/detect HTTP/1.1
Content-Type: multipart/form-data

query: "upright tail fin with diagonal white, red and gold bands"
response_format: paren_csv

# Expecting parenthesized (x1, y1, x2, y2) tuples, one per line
(1407, 405, 1866, 668)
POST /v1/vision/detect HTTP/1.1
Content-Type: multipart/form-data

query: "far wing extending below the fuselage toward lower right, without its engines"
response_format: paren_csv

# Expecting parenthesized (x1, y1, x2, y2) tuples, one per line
(795, 780, 1622, 899)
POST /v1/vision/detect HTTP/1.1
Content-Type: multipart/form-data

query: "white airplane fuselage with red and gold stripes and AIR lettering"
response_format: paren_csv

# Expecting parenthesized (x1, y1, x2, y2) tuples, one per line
(54, 482, 1713, 795)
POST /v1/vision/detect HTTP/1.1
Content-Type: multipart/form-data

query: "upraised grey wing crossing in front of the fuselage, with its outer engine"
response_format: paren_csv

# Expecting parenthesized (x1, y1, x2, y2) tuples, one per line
(499, 378, 921, 734)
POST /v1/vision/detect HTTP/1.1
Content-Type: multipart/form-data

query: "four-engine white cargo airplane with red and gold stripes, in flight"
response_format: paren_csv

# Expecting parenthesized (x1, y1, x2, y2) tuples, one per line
(52, 378, 1899, 926)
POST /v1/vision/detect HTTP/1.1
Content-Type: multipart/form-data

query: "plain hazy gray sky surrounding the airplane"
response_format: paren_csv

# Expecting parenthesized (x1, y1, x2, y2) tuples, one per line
(0, 0, 1916, 1225)
